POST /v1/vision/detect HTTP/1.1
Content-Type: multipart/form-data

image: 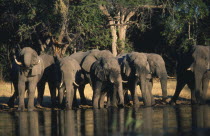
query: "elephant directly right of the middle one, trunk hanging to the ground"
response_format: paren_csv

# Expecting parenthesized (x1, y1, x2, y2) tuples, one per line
(118, 52, 155, 107)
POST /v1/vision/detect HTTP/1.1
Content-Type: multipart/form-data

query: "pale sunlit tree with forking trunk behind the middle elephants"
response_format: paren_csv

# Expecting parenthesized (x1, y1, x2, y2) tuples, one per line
(99, 0, 163, 56)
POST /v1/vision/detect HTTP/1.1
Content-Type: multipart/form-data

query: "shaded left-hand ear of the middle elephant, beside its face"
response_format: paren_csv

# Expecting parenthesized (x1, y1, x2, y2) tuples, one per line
(92, 60, 106, 81)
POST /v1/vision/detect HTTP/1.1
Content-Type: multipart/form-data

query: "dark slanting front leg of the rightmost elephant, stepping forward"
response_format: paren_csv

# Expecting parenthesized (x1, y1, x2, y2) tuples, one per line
(169, 79, 186, 105)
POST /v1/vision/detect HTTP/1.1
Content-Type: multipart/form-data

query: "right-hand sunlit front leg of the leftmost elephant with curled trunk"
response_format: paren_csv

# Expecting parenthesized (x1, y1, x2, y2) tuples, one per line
(28, 81, 37, 111)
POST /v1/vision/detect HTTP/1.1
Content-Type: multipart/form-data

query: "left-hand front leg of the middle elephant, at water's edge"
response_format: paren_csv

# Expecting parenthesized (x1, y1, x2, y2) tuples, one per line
(93, 81, 102, 109)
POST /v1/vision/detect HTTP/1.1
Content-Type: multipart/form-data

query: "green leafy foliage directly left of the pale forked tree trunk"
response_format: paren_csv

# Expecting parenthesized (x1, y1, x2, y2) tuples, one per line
(69, 0, 111, 50)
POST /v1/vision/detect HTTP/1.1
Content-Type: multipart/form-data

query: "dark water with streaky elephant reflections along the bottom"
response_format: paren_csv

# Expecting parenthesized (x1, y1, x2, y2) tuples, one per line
(0, 105, 210, 136)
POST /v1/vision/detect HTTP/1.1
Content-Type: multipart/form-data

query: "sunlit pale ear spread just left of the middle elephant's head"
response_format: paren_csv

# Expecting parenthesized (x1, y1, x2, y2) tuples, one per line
(82, 55, 96, 72)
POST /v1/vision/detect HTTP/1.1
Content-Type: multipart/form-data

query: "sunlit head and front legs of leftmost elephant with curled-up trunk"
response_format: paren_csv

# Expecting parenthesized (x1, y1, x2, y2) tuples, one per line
(14, 47, 44, 111)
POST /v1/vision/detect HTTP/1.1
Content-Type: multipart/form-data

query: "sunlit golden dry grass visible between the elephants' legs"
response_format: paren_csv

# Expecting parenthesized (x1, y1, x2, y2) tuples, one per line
(0, 79, 210, 103)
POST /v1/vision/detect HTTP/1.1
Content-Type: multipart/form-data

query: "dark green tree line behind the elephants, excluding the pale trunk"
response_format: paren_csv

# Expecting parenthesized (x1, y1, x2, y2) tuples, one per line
(0, 0, 210, 81)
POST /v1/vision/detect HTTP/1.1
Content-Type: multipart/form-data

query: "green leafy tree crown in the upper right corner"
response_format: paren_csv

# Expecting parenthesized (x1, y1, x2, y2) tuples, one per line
(162, 0, 209, 48)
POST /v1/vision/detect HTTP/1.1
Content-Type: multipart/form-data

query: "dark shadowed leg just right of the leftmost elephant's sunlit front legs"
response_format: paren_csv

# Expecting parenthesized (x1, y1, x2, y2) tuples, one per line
(36, 82, 45, 107)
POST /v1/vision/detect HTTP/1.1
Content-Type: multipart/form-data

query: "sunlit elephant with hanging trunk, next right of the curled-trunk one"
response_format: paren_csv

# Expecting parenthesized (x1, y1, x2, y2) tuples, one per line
(58, 56, 84, 110)
